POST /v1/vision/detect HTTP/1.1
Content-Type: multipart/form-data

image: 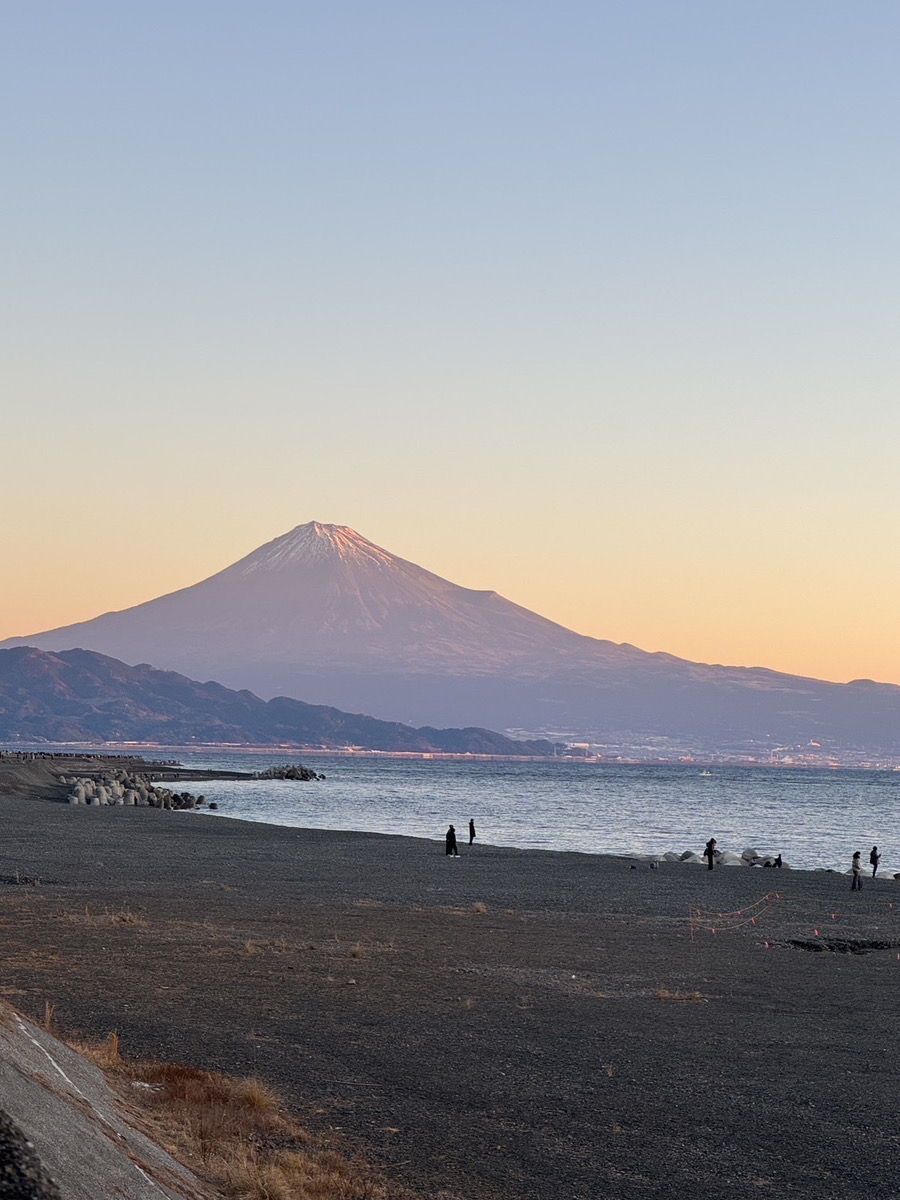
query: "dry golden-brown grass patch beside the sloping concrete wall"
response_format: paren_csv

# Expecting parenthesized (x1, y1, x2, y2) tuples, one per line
(72, 1033, 416, 1200)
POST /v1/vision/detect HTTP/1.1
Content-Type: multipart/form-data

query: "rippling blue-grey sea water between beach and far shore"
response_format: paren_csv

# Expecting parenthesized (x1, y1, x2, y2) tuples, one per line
(158, 750, 900, 875)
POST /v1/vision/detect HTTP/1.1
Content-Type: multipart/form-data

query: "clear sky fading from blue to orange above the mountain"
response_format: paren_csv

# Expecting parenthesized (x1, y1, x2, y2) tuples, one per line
(0, 0, 900, 683)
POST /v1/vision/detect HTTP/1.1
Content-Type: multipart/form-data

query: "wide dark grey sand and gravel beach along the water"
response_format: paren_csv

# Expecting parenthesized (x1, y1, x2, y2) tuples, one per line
(0, 767, 900, 1200)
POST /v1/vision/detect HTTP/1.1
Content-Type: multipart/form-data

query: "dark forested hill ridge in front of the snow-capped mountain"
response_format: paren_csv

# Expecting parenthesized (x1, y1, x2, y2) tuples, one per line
(0, 647, 553, 755)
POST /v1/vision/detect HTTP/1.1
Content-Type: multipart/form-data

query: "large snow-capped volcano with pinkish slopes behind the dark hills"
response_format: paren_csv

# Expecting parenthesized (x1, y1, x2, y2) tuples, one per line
(7, 521, 900, 754)
